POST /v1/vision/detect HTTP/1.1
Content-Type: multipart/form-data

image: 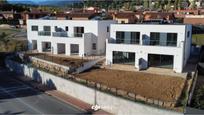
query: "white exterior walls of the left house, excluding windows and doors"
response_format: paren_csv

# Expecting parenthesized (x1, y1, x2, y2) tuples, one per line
(27, 20, 115, 56)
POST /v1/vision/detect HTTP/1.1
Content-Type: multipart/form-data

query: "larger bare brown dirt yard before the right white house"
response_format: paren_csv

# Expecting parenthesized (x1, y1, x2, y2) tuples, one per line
(77, 69, 185, 101)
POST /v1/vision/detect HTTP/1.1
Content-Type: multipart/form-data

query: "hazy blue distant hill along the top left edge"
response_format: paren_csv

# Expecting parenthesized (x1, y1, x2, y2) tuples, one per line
(7, 0, 82, 6)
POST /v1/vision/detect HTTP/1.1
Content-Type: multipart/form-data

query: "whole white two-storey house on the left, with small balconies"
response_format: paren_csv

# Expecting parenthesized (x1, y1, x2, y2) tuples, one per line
(27, 19, 116, 56)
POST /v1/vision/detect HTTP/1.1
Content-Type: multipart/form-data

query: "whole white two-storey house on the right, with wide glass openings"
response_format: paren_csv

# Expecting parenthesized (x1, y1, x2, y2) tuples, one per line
(106, 24, 192, 73)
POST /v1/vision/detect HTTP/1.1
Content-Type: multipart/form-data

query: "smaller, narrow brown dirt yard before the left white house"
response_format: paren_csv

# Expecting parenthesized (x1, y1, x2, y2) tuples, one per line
(27, 53, 88, 67)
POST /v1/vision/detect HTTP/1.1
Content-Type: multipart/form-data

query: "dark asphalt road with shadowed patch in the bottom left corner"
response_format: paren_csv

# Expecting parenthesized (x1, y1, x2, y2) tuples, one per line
(0, 68, 85, 114)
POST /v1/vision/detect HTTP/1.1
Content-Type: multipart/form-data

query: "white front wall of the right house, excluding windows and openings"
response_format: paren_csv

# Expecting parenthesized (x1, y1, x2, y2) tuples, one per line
(106, 24, 191, 73)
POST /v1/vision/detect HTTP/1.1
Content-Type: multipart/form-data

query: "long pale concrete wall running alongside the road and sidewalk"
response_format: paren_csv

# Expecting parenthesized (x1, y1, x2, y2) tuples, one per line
(6, 60, 183, 115)
